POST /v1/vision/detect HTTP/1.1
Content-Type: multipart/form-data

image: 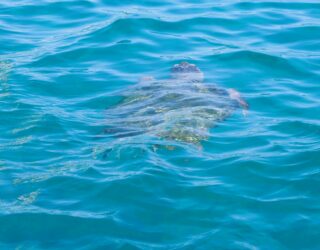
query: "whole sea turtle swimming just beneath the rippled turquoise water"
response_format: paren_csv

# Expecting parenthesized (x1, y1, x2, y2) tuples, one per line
(105, 62, 248, 148)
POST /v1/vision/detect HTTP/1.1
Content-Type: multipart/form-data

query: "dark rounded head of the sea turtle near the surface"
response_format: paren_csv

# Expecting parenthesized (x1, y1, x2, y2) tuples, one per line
(171, 62, 203, 82)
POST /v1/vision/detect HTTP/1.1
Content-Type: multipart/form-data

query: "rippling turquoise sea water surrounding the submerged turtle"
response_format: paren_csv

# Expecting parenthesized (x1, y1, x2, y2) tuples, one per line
(0, 0, 320, 249)
